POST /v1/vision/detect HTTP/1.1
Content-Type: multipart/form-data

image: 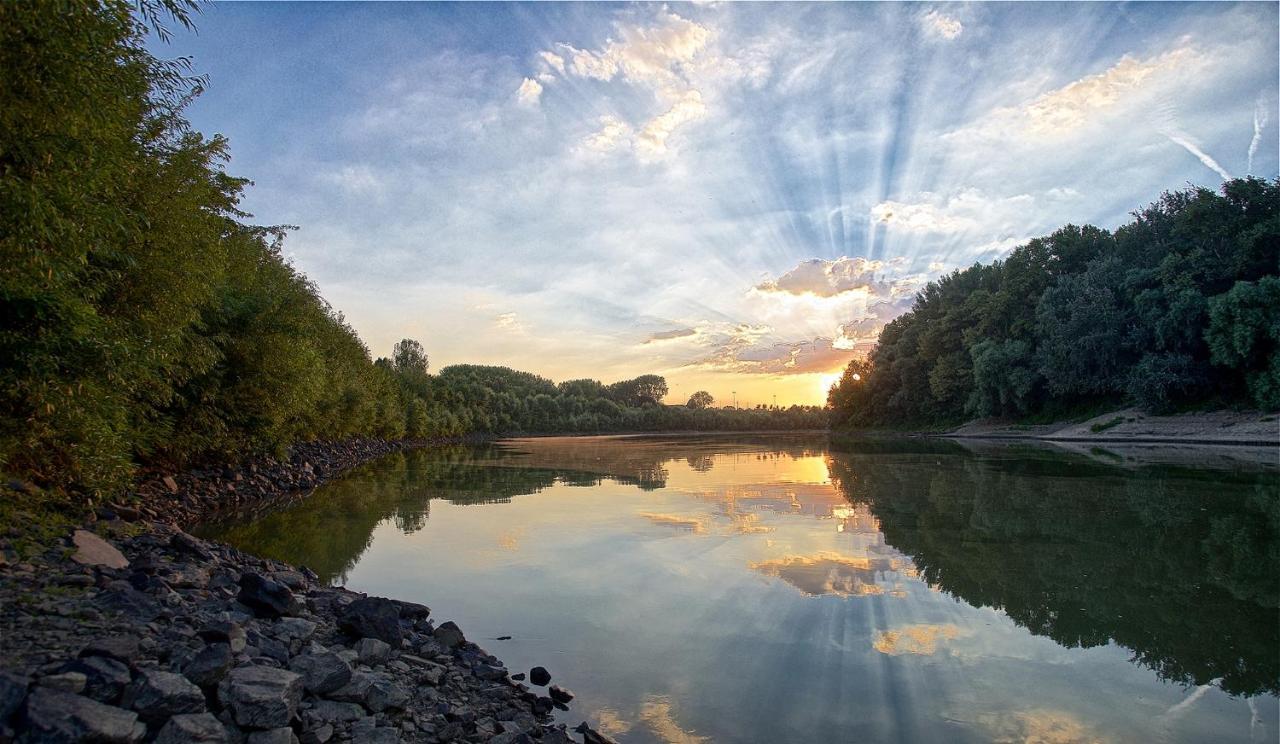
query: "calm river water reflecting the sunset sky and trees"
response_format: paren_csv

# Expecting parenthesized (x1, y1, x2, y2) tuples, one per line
(199, 437, 1280, 743)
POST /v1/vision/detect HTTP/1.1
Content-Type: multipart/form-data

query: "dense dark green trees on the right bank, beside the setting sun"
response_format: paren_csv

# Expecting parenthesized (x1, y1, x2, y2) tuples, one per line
(828, 178, 1280, 426)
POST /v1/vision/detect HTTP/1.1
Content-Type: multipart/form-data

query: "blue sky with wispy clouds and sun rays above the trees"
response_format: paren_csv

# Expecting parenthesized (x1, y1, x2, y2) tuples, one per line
(151, 3, 1280, 406)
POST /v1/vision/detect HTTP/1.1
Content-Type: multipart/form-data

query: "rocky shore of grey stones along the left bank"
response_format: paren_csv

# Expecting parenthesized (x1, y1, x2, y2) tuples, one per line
(0, 442, 619, 744)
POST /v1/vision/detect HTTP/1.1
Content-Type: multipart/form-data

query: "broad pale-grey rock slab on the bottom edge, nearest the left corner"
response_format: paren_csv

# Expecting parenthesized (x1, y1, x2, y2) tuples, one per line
(26, 688, 147, 744)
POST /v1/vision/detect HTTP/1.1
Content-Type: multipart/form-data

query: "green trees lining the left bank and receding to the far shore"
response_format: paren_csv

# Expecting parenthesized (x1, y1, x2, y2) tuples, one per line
(0, 0, 823, 496)
